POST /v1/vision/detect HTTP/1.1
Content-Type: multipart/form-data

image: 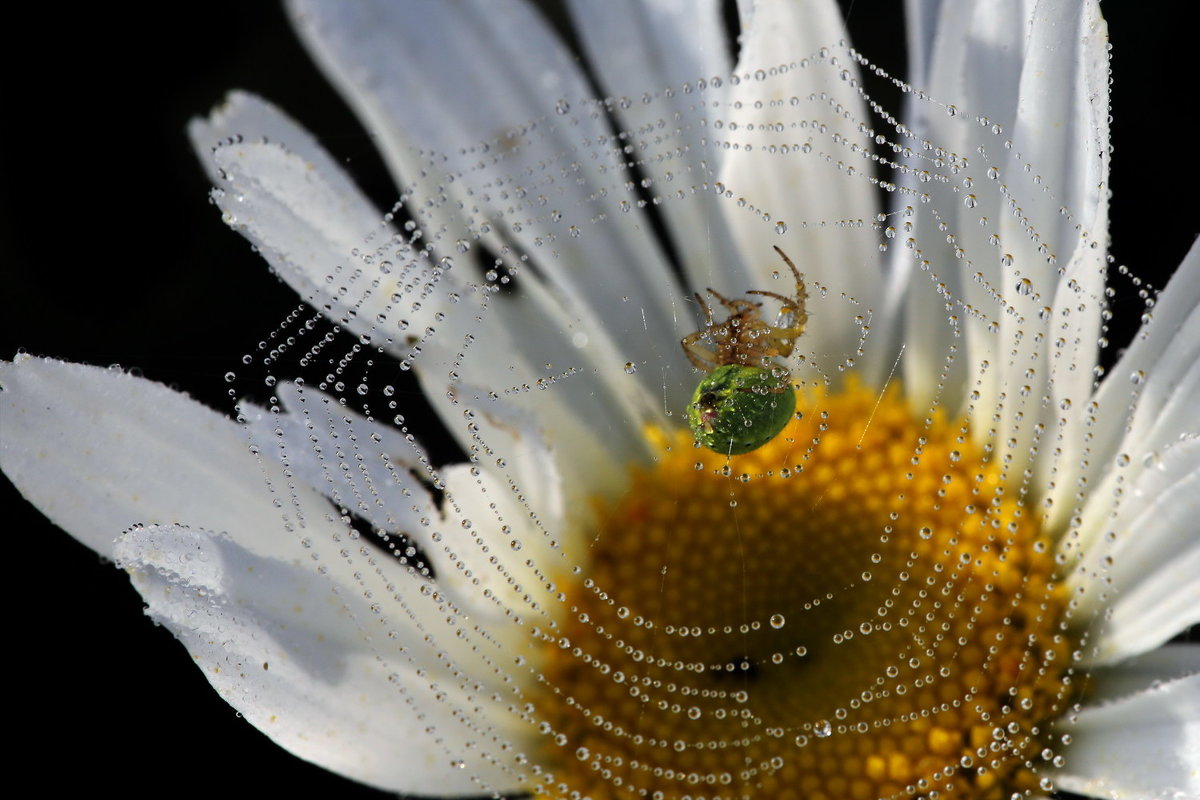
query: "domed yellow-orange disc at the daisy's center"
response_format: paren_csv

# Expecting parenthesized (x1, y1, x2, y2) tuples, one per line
(532, 386, 1075, 800)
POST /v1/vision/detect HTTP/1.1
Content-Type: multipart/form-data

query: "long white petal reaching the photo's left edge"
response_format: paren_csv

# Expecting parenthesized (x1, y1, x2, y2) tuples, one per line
(0, 356, 532, 700)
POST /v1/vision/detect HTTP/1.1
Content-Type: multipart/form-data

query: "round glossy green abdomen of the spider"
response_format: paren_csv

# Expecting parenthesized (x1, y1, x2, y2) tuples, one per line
(688, 363, 796, 456)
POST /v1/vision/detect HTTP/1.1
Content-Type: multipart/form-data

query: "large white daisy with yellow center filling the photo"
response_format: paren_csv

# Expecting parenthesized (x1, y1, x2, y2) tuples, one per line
(0, 0, 1200, 800)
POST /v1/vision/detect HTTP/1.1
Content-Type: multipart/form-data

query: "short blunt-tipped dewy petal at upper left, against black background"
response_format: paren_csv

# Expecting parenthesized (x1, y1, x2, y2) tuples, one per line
(188, 92, 520, 407)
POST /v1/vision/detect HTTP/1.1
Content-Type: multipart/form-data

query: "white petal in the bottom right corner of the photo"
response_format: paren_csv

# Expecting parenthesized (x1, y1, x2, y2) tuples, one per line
(1055, 674, 1200, 800)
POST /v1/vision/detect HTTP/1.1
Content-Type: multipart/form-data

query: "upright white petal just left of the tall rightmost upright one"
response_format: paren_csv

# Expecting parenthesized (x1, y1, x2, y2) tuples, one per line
(890, 2, 1030, 413)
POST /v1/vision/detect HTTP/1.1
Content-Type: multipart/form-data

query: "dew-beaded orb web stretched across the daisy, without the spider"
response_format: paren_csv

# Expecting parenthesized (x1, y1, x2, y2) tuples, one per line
(199, 14, 1180, 800)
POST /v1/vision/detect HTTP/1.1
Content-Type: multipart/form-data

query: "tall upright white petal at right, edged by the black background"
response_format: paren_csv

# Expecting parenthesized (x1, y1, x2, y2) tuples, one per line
(998, 0, 1109, 476)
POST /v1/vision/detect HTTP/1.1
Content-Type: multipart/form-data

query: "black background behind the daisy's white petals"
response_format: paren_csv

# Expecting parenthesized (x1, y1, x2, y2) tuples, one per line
(0, 2, 1200, 796)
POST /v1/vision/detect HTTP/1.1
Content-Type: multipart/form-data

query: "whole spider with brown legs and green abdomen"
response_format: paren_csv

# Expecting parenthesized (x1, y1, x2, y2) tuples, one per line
(679, 247, 809, 456)
